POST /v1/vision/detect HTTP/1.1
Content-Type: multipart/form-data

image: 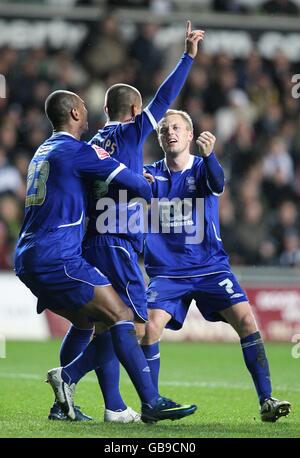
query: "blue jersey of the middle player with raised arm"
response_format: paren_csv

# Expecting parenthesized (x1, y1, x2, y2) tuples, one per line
(87, 53, 193, 251)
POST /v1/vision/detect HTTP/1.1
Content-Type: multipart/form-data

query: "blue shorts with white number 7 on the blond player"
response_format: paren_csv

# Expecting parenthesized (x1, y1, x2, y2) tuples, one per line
(147, 272, 248, 330)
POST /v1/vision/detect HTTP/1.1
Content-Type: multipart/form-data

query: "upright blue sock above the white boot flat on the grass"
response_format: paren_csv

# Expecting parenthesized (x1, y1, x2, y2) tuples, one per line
(96, 331, 127, 411)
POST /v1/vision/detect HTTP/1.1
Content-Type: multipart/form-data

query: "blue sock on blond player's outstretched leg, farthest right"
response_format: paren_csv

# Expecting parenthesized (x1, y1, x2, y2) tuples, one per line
(241, 332, 272, 404)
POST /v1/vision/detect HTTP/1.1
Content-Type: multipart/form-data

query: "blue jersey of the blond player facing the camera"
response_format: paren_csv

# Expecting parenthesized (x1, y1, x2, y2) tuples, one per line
(145, 154, 230, 278)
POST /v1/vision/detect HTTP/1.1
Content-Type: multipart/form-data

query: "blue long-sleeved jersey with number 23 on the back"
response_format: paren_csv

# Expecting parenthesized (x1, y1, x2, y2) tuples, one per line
(15, 132, 151, 273)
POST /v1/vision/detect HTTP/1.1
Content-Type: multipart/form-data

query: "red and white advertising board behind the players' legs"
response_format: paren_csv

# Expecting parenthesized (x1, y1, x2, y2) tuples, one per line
(41, 284, 300, 342)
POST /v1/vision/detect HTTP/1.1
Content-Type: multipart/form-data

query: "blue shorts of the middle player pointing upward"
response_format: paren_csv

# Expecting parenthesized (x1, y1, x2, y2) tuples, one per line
(83, 235, 148, 322)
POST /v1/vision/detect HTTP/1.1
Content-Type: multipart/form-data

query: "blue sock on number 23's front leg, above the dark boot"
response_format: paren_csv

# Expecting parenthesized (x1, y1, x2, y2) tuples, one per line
(110, 321, 159, 405)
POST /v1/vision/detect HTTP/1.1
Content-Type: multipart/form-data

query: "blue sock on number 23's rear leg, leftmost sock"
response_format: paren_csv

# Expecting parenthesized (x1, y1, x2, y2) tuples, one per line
(59, 325, 93, 366)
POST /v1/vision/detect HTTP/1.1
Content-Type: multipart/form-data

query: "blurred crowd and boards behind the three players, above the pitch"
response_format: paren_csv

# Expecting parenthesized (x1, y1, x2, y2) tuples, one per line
(0, 0, 300, 340)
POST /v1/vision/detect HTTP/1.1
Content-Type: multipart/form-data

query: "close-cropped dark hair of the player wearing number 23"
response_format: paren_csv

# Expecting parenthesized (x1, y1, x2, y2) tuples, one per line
(45, 90, 78, 129)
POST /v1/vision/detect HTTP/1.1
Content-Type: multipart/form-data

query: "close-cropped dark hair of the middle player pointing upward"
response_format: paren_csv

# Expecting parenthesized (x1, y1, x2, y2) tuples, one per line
(105, 84, 140, 120)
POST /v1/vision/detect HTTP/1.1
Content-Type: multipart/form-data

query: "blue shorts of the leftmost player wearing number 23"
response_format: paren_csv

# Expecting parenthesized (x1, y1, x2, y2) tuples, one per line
(18, 257, 111, 313)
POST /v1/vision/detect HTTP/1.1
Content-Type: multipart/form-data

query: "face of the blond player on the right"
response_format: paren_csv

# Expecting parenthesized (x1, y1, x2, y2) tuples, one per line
(158, 114, 193, 156)
